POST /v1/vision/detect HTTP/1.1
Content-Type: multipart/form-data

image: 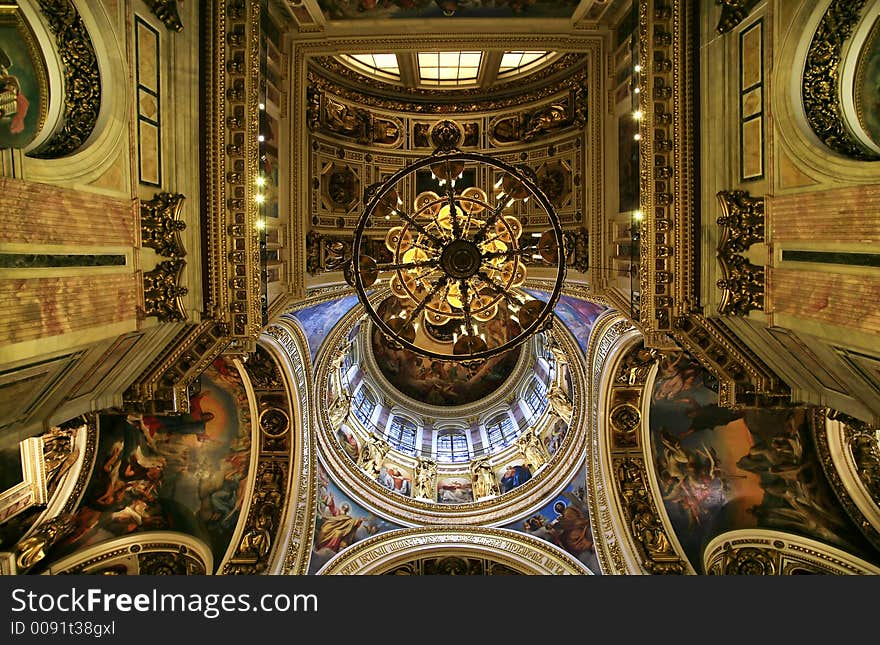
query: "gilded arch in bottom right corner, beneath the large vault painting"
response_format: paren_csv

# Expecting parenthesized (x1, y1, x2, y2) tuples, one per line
(703, 529, 880, 576)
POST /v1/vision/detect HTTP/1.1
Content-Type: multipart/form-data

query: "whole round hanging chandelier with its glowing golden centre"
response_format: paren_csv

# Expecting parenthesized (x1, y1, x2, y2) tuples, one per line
(345, 125, 565, 361)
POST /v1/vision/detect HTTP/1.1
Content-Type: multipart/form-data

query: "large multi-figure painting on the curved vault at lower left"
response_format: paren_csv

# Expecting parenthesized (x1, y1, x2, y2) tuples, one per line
(53, 358, 251, 565)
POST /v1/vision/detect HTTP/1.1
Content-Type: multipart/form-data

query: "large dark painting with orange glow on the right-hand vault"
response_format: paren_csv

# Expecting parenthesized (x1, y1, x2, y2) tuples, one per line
(650, 353, 880, 572)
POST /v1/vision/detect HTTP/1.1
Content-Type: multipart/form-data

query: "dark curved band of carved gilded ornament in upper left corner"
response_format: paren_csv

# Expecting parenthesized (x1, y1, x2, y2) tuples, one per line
(28, 0, 101, 159)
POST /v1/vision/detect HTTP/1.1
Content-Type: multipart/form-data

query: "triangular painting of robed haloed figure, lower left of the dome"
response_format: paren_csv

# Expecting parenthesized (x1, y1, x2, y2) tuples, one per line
(308, 464, 400, 574)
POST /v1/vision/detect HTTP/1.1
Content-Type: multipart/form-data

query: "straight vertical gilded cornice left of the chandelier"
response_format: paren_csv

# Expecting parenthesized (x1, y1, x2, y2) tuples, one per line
(203, 0, 263, 340)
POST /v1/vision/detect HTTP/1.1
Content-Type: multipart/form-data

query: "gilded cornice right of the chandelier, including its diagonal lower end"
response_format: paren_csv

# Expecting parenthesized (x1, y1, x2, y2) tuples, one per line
(632, 0, 789, 406)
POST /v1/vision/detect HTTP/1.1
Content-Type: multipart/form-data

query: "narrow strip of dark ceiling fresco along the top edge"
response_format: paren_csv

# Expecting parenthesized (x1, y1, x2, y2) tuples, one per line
(318, 0, 579, 20)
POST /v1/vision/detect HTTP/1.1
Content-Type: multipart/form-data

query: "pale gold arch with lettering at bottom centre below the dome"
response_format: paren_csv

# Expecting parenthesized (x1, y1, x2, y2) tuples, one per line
(318, 527, 590, 575)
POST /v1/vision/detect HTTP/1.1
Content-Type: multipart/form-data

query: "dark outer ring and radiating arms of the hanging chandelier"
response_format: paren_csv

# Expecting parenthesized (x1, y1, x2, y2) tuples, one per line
(345, 149, 566, 362)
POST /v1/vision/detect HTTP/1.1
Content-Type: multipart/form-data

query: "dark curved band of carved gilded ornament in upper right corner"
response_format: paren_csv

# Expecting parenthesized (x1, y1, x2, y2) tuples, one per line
(801, 0, 880, 161)
